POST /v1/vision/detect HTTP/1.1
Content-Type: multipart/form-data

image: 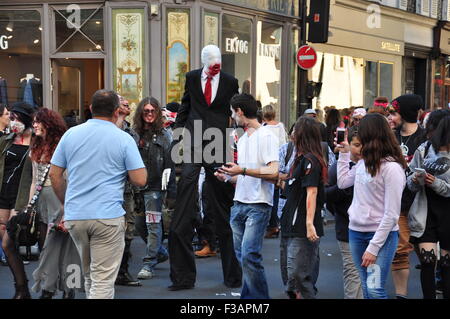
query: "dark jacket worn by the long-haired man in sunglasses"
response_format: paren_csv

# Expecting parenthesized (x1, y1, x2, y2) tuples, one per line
(139, 128, 176, 198)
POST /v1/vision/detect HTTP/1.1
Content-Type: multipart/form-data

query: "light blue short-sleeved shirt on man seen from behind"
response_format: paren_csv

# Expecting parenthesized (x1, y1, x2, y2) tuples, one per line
(51, 119, 145, 220)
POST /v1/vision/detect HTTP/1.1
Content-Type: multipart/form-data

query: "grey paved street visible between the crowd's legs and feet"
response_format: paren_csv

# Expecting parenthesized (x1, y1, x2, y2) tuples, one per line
(0, 224, 422, 299)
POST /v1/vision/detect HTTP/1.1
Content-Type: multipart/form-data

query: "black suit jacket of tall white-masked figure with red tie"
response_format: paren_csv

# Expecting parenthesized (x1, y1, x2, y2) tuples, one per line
(175, 68, 239, 154)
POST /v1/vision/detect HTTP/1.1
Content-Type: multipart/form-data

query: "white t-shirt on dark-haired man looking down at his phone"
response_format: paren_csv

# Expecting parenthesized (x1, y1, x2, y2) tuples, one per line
(234, 126, 279, 206)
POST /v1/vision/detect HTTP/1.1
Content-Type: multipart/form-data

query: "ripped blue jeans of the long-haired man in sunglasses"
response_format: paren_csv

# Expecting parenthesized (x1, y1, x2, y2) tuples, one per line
(143, 191, 168, 271)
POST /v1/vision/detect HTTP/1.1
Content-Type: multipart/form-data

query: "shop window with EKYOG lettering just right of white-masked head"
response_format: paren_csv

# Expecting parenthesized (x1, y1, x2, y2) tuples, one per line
(222, 14, 252, 94)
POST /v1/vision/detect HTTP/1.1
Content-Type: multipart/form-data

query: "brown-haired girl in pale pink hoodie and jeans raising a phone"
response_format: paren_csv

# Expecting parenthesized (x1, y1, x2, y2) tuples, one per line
(337, 113, 406, 299)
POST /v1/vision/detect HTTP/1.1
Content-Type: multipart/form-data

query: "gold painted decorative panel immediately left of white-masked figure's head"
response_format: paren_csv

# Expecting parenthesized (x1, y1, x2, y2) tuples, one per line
(166, 9, 190, 103)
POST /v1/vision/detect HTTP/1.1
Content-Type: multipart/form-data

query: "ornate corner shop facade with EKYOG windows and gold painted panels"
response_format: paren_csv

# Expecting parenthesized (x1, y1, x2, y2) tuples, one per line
(0, 0, 298, 127)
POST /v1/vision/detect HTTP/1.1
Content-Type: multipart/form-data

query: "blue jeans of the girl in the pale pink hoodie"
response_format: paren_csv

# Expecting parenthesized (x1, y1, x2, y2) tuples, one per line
(348, 229, 398, 299)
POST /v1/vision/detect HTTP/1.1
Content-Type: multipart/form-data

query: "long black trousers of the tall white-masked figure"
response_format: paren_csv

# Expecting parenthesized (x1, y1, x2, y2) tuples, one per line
(169, 163, 242, 287)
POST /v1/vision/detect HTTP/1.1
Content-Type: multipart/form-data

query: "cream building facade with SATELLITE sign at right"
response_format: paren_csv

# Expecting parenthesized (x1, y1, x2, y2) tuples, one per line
(310, 0, 450, 108)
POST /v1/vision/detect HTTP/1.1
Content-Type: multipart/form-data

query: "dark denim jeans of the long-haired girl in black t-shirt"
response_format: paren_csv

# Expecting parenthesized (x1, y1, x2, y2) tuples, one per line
(287, 237, 320, 299)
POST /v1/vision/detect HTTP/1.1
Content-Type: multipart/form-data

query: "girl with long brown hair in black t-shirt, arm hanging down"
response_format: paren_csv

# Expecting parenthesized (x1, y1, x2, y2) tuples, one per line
(281, 117, 327, 299)
